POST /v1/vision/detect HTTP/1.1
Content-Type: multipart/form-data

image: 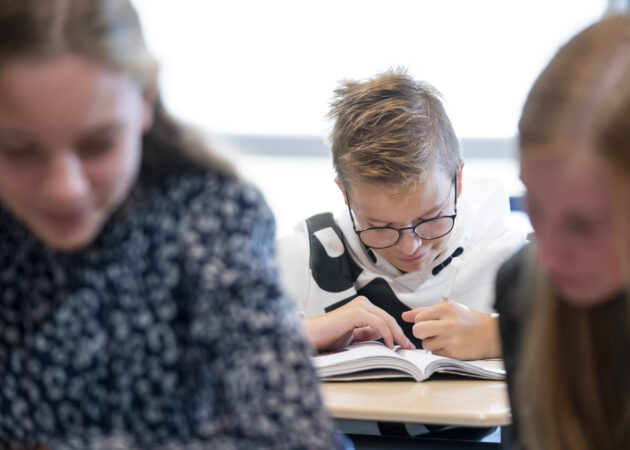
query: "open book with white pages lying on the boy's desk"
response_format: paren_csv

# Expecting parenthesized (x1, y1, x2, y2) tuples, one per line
(312, 341, 505, 381)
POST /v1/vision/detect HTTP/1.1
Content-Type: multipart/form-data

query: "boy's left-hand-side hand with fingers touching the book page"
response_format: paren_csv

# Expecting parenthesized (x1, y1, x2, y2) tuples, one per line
(302, 296, 415, 350)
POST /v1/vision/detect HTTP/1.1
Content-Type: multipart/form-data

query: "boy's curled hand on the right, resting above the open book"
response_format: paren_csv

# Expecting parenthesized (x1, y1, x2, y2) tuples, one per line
(402, 300, 501, 359)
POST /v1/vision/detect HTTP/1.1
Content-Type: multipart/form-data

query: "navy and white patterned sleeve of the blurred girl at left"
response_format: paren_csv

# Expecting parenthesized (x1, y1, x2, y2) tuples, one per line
(177, 182, 343, 449)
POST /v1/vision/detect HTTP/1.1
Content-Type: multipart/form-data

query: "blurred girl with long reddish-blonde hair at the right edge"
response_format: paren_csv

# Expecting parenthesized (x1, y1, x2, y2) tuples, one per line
(497, 17, 630, 449)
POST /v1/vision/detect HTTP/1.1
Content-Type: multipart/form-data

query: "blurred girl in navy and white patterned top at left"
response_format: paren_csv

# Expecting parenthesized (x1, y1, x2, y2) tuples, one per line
(0, 0, 346, 449)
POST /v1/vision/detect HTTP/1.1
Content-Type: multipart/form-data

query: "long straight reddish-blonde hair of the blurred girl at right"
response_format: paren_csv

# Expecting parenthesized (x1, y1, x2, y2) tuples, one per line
(516, 16, 630, 450)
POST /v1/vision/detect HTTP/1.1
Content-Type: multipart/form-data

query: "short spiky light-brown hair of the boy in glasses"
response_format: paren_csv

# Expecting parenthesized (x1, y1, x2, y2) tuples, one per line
(328, 70, 461, 187)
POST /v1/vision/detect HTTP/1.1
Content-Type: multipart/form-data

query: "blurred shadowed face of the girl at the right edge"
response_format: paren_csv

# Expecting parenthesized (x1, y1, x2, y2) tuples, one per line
(521, 149, 630, 307)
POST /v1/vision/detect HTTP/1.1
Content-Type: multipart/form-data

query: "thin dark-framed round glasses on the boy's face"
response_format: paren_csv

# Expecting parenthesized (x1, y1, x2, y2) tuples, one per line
(344, 172, 457, 250)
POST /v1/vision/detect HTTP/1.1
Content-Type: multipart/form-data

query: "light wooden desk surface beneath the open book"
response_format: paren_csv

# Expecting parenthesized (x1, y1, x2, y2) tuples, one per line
(321, 379, 511, 426)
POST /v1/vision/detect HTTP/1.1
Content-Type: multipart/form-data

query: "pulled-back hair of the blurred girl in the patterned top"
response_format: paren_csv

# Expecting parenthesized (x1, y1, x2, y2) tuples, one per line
(0, 0, 232, 182)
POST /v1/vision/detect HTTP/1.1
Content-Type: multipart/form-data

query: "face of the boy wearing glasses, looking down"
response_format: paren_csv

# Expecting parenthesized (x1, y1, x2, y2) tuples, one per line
(340, 168, 461, 272)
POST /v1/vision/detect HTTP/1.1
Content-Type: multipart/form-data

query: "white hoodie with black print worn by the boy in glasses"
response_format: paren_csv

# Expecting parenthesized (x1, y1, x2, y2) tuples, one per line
(278, 179, 526, 316)
